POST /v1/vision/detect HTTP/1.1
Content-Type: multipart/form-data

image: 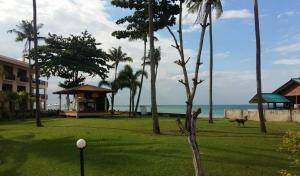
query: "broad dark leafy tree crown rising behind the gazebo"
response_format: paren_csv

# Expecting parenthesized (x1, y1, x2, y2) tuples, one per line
(29, 31, 111, 88)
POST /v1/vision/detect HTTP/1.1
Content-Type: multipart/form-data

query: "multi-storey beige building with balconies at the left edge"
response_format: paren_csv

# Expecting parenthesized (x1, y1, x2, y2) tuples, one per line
(0, 55, 48, 110)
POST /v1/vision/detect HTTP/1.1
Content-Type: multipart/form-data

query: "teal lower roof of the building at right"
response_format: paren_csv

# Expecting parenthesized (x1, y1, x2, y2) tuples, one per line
(249, 93, 290, 103)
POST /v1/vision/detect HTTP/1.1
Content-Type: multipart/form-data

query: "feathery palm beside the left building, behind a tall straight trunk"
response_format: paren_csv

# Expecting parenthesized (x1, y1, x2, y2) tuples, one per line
(7, 20, 45, 113)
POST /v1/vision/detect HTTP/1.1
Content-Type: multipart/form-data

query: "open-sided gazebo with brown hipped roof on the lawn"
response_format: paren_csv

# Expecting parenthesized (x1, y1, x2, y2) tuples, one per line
(53, 85, 113, 117)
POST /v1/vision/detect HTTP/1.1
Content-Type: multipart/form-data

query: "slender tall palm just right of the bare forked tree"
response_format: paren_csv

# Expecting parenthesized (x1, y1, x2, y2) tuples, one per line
(187, 0, 223, 123)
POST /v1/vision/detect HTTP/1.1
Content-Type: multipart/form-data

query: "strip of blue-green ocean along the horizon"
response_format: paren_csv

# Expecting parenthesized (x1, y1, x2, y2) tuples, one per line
(115, 105, 257, 117)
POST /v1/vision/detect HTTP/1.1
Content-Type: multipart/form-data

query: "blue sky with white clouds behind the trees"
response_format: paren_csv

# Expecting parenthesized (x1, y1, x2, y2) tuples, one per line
(0, 0, 300, 104)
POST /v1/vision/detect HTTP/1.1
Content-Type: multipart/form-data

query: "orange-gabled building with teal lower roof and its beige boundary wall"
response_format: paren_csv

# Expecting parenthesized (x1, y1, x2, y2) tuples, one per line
(224, 78, 300, 122)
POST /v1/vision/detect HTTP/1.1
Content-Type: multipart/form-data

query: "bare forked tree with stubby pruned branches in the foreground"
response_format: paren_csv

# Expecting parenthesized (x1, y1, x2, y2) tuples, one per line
(168, 0, 211, 176)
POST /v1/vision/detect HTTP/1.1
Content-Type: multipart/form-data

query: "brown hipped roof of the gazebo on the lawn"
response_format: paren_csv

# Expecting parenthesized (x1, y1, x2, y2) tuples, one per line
(53, 85, 113, 94)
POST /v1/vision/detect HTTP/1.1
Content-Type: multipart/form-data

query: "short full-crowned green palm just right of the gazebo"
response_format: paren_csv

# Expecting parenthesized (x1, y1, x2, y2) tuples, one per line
(118, 65, 148, 116)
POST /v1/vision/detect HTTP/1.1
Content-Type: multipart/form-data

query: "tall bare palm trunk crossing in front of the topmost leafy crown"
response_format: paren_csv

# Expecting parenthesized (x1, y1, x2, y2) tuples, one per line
(148, 0, 160, 134)
